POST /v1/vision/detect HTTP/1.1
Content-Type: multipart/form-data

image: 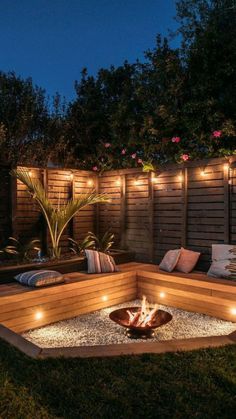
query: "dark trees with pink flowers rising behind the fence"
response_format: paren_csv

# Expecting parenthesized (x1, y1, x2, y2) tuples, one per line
(0, 0, 236, 170)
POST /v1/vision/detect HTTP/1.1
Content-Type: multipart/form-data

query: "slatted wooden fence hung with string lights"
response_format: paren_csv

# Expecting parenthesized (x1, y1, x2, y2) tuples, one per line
(0, 156, 236, 269)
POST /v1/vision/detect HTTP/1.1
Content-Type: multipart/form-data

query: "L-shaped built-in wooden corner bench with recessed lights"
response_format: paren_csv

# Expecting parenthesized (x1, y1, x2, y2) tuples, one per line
(0, 262, 236, 333)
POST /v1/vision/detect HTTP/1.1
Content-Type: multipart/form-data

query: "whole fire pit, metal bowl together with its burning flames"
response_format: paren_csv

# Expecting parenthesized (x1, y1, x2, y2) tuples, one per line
(109, 297, 172, 339)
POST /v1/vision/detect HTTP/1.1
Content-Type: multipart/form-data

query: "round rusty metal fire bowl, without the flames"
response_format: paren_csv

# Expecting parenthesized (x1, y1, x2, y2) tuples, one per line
(109, 307, 172, 338)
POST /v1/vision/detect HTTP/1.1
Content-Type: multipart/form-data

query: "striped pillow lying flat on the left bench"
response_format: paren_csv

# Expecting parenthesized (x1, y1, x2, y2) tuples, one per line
(15, 270, 64, 287)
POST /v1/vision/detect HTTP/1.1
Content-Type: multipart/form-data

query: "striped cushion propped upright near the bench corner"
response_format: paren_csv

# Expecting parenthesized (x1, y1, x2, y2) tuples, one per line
(85, 249, 119, 274)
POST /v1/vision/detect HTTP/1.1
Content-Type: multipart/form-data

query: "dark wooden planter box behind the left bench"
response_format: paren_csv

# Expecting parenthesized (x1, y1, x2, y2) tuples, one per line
(0, 250, 134, 284)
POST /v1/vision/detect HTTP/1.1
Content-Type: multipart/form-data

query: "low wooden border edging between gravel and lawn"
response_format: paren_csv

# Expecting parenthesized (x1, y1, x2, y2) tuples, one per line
(0, 324, 236, 359)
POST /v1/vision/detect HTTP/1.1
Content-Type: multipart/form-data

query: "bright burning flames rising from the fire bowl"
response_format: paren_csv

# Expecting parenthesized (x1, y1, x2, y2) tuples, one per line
(127, 295, 158, 327)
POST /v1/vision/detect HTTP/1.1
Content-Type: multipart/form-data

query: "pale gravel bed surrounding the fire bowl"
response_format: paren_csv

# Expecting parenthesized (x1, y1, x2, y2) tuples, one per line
(23, 300, 236, 348)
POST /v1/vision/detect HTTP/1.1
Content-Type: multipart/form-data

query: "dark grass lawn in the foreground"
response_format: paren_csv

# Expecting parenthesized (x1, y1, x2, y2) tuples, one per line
(0, 341, 236, 419)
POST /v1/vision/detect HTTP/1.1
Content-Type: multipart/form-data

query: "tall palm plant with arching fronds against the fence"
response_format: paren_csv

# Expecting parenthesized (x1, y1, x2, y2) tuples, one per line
(11, 169, 109, 258)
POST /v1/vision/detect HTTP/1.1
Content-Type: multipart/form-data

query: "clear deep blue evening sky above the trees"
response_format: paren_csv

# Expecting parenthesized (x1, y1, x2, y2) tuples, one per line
(0, 0, 176, 100)
